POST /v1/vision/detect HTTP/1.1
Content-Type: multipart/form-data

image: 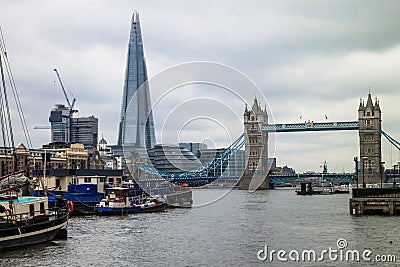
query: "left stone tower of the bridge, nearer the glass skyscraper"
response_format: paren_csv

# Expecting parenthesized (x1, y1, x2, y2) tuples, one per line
(238, 97, 269, 190)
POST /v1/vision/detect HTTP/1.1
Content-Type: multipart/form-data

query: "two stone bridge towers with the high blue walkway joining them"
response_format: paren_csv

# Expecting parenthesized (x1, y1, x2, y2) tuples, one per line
(239, 91, 388, 189)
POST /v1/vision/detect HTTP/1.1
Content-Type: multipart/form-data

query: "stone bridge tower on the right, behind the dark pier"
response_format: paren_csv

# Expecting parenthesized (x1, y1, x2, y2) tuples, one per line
(358, 91, 382, 184)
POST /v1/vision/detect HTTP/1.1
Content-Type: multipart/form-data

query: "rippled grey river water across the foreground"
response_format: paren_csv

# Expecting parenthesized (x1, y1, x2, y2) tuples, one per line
(0, 189, 400, 266)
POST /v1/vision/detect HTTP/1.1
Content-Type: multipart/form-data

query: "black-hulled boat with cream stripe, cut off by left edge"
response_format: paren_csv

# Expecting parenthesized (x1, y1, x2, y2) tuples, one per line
(0, 195, 68, 250)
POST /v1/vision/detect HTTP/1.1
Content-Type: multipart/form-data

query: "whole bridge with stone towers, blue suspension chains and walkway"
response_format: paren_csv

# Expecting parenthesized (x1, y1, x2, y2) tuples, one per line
(135, 92, 400, 189)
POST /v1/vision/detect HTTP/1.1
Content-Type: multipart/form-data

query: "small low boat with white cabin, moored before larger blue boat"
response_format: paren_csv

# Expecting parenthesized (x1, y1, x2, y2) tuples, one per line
(95, 187, 167, 215)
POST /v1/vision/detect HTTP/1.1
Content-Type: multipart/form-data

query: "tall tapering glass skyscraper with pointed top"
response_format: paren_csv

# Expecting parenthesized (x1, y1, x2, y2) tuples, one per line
(117, 11, 156, 149)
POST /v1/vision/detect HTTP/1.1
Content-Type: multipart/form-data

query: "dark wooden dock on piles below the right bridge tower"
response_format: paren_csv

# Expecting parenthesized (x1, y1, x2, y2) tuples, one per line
(349, 188, 400, 216)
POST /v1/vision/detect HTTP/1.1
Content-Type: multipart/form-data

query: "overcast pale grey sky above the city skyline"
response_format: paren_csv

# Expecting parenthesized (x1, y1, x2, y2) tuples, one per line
(0, 0, 400, 172)
